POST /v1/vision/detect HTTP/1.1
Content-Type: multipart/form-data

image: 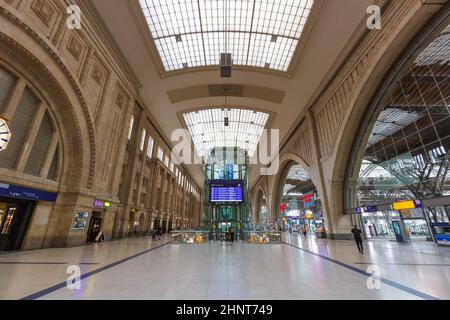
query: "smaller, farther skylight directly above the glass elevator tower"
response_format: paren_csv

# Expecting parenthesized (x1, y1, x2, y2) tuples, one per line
(183, 108, 269, 157)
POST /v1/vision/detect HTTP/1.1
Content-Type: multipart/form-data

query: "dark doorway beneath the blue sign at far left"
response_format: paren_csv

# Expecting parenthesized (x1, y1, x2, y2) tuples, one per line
(0, 197, 35, 251)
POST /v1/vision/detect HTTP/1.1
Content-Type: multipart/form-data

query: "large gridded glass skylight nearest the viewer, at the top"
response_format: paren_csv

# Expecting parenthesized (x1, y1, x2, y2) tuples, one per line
(139, 0, 314, 72)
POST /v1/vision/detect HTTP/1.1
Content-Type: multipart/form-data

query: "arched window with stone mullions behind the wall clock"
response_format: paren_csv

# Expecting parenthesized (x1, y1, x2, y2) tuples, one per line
(0, 67, 60, 180)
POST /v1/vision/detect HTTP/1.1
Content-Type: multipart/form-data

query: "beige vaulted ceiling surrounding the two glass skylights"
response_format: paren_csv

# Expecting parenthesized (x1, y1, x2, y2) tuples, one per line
(92, 0, 374, 187)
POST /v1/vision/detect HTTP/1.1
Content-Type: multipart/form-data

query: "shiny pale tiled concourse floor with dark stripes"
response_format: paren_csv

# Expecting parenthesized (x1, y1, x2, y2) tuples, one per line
(0, 235, 450, 300)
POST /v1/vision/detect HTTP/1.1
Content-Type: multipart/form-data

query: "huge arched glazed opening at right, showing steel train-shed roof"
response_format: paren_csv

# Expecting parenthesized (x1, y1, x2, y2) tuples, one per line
(345, 22, 450, 240)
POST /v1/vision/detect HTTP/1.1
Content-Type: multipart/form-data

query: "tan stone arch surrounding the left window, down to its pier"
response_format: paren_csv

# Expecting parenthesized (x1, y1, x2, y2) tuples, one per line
(0, 22, 95, 248)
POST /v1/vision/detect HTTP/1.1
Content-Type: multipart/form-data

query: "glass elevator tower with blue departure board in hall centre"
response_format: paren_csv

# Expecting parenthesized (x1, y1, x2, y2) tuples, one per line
(203, 147, 251, 240)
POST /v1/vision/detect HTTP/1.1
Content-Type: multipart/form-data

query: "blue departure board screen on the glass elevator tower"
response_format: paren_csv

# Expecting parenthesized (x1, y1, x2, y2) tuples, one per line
(209, 180, 244, 202)
